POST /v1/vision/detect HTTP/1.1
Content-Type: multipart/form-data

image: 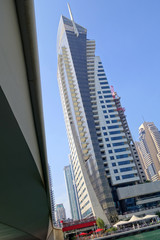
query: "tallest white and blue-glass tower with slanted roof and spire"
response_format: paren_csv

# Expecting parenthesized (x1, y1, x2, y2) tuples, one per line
(57, 12, 140, 224)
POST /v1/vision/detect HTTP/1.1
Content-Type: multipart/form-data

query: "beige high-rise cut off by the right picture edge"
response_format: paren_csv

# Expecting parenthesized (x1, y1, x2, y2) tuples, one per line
(135, 122, 160, 182)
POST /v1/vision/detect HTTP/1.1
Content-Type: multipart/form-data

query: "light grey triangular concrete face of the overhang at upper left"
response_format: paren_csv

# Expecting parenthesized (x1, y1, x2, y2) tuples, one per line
(0, 0, 42, 180)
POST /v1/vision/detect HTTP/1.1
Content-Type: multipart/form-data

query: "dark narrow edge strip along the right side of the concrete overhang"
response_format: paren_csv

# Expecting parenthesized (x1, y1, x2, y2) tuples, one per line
(15, 0, 51, 206)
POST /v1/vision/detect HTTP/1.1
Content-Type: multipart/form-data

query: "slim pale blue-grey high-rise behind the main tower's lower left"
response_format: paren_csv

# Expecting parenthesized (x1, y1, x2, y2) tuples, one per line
(64, 165, 80, 220)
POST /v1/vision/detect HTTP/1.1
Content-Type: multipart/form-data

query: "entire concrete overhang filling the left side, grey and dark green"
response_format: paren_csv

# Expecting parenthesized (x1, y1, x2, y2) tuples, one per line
(0, 0, 53, 240)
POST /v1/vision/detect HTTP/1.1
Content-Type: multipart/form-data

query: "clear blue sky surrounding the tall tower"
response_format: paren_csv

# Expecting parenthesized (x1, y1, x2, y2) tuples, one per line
(35, 0, 160, 217)
